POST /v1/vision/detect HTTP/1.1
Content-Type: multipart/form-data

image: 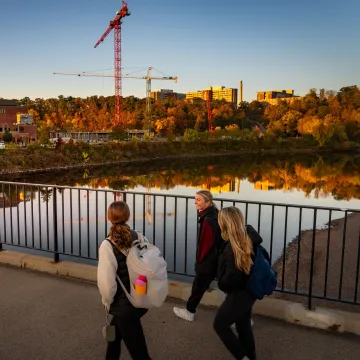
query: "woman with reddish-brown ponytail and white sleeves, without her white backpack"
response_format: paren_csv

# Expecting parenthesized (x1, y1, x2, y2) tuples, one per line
(97, 201, 151, 360)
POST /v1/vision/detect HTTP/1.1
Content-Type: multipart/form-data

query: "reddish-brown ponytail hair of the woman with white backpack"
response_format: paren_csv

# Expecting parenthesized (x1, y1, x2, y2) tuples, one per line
(108, 201, 132, 250)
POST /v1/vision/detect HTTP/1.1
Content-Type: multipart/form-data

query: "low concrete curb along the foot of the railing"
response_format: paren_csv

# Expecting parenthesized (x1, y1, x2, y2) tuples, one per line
(0, 250, 360, 335)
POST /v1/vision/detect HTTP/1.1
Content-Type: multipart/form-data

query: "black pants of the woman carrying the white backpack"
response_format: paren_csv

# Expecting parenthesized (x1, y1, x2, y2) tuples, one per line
(105, 308, 151, 360)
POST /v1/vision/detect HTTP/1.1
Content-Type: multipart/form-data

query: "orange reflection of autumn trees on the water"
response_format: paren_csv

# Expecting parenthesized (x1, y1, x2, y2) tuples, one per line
(4, 153, 360, 201)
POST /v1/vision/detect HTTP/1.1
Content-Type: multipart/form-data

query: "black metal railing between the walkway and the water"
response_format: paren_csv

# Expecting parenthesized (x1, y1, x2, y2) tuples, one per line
(0, 181, 360, 308)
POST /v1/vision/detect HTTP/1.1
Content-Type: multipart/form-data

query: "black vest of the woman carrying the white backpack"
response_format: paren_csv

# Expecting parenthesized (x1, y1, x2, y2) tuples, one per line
(109, 230, 138, 315)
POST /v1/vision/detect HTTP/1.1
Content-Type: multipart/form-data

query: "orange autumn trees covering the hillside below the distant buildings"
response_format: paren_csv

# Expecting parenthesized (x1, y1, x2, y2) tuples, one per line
(13, 85, 360, 146)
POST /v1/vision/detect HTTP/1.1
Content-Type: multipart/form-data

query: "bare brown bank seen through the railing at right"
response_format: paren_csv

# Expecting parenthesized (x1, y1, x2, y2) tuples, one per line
(273, 212, 360, 312)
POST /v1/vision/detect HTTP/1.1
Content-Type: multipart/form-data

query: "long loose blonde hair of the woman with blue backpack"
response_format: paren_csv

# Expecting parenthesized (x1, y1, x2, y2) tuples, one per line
(219, 206, 253, 274)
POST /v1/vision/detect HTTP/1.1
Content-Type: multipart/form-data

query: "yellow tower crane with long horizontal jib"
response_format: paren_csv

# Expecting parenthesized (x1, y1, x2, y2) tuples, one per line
(53, 66, 178, 135)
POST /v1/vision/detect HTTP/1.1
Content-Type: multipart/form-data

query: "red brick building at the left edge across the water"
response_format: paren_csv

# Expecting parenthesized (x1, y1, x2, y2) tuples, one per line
(0, 99, 37, 141)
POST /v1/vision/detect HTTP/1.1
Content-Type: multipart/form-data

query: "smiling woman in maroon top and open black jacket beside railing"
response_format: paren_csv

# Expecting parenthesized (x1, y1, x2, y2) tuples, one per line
(174, 190, 224, 321)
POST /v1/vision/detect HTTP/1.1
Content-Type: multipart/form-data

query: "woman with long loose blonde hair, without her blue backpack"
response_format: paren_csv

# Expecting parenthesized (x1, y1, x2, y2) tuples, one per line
(214, 207, 262, 360)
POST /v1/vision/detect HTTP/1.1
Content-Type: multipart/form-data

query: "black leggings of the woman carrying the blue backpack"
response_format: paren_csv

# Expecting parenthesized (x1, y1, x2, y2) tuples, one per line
(214, 290, 256, 360)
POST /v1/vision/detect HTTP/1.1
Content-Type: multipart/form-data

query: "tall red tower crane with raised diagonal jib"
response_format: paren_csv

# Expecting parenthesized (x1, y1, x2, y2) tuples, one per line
(94, 1, 130, 126)
